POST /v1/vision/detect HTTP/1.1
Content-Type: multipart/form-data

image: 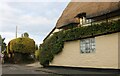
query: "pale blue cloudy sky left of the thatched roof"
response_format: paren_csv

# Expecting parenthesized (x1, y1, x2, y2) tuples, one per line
(0, 0, 69, 45)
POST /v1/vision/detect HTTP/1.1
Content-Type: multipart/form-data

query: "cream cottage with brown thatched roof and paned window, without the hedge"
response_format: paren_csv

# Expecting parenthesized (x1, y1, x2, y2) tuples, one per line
(43, 2, 120, 69)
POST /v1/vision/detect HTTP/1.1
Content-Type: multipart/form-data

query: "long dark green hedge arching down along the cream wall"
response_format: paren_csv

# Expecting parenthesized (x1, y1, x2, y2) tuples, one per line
(40, 20, 120, 66)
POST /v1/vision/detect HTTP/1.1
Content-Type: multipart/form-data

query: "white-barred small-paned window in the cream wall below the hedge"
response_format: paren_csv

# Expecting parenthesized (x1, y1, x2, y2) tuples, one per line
(80, 38, 95, 53)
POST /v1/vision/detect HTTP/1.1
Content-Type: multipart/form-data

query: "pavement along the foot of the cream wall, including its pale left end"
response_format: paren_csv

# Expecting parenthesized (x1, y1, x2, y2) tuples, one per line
(26, 62, 118, 74)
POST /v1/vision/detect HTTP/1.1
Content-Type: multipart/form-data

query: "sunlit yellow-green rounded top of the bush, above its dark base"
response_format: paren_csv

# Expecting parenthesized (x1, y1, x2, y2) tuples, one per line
(8, 38, 35, 53)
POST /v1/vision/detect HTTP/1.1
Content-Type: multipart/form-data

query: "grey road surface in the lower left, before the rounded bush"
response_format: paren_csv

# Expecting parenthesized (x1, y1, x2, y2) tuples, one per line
(2, 64, 49, 74)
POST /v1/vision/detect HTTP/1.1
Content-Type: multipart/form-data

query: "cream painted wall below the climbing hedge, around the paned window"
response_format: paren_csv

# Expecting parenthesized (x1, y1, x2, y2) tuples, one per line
(50, 33, 118, 69)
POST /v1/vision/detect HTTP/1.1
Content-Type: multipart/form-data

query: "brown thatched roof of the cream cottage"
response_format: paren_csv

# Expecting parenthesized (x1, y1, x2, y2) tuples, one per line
(56, 2, 120, 28)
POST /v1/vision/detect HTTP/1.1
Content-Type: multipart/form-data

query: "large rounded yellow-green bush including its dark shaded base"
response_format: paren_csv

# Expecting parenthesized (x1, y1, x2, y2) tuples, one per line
(7, 37, 35, 63)
